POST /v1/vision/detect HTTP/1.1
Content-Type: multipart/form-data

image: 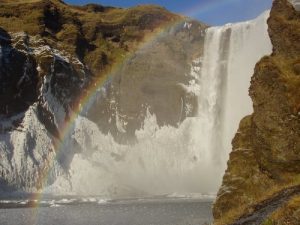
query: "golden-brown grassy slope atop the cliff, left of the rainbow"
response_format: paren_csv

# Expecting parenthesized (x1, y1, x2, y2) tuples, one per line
(0, 0, 181, 74)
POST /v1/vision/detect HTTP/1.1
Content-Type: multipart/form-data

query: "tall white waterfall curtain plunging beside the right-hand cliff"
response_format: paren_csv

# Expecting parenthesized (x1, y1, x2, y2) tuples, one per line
(199, 11, 272, 172)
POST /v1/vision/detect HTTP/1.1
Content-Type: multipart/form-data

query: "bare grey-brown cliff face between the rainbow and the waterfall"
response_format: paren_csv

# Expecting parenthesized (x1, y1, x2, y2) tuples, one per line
(87, 22, 206, 143)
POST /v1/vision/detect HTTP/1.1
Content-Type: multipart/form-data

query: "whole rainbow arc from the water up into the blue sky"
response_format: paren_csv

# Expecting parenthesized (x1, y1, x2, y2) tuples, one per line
(25, 0, 272, 224)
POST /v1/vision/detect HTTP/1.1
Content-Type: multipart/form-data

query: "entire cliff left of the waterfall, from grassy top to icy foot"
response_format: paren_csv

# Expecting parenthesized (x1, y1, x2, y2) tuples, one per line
(0, 0, 206, 191)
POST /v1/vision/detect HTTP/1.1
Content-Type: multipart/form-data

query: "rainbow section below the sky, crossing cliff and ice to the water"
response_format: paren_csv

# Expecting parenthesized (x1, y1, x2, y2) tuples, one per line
(31, 7, 189, 221)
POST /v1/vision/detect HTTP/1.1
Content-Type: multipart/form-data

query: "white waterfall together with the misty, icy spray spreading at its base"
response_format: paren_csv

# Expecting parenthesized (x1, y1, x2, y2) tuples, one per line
(50, 12, 272, 197)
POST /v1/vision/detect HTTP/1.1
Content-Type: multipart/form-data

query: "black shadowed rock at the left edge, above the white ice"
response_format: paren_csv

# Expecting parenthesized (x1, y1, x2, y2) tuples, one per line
(0, 29, 38, 116)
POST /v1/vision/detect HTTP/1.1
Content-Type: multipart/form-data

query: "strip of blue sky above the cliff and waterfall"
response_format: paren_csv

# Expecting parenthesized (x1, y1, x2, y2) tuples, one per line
(65, 0, 272, 25)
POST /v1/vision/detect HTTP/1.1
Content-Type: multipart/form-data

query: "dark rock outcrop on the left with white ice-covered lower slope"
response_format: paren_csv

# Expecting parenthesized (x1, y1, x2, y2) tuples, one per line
(0, 31, 89, 191)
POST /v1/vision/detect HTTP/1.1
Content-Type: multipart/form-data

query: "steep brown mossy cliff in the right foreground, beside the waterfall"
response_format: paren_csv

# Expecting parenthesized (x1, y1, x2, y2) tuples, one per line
(213, 0, 300, 224)
